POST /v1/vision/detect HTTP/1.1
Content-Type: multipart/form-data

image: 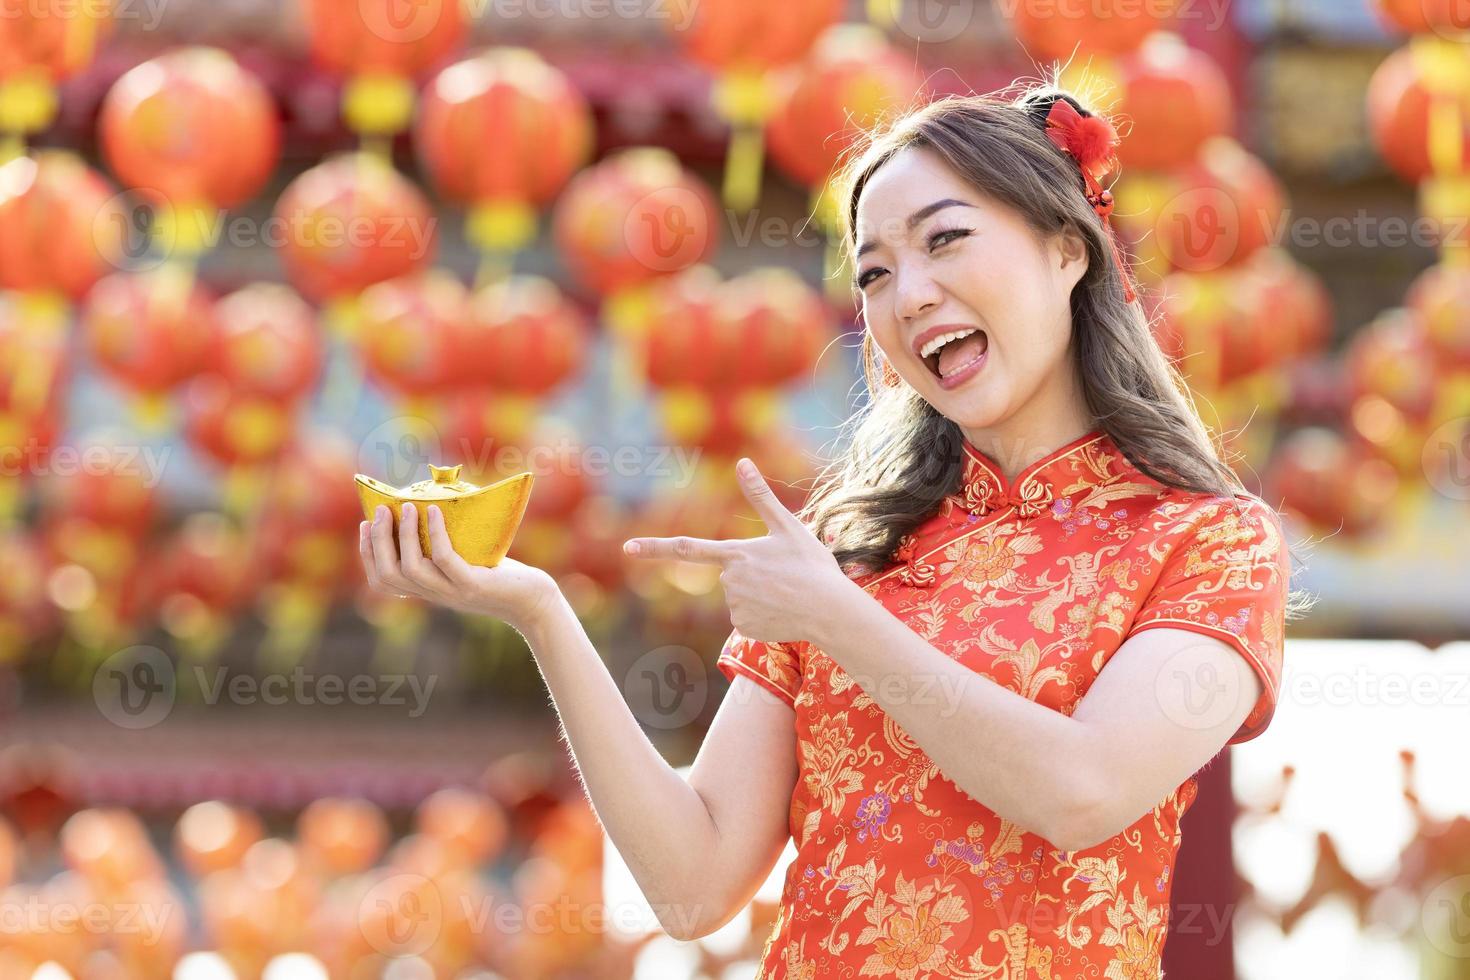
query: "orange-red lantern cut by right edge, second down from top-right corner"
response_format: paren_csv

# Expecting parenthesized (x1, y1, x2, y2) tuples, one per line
(1367, 35, 1470, 184)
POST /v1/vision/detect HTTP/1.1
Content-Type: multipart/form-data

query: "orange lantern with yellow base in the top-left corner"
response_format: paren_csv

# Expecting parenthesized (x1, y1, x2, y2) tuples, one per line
(0, 0, 113, 154)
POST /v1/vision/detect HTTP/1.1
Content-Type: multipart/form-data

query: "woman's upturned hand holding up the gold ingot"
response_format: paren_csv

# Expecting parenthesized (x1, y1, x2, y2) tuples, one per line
(357, 504, 560, 633)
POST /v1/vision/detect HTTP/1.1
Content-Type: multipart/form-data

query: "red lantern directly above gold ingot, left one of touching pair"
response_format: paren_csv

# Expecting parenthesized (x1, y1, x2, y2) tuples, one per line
(357, 269, 469, 395)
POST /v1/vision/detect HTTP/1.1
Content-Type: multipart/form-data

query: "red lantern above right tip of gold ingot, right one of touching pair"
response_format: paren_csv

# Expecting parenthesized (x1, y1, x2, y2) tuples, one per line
(456, 276, 591, 398)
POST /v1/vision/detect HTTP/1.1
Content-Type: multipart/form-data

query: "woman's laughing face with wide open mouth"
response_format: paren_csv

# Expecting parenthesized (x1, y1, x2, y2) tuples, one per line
(857, 147, 1086, 444)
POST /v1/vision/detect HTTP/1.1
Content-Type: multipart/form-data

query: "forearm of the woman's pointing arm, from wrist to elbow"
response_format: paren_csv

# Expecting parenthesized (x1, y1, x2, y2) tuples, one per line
(816, 585, 1101, 846)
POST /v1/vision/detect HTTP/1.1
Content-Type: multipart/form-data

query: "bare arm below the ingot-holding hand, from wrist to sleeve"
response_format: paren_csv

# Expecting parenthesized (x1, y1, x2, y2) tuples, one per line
(525, 590, 797, 940)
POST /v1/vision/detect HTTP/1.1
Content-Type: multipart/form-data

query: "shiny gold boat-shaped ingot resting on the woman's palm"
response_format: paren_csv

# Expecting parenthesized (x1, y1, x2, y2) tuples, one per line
(356, 464, 532, 569)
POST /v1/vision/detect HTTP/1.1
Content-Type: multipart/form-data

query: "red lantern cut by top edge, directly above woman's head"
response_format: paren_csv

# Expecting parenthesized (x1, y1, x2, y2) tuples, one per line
(1010, 0, 1179, 62)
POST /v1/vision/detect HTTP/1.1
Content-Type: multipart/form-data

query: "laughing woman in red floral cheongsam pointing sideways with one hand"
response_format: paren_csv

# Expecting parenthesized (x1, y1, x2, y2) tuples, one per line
(362, 88, 1289, 980)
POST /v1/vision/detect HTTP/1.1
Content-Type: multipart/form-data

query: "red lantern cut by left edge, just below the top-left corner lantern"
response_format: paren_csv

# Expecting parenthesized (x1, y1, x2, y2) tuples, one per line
(0, 151, 128, 300)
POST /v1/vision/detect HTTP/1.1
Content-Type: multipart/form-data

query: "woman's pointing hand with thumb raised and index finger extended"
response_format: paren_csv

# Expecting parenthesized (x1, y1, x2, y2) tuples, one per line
(623, 458, 853, 644)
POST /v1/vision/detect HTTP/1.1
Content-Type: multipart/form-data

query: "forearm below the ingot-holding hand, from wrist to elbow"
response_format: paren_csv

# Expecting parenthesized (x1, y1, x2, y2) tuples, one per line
(523, 597, 719, 933)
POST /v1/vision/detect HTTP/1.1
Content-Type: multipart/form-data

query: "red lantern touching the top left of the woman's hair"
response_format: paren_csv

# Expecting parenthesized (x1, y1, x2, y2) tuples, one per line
(769, 24, 923, 187)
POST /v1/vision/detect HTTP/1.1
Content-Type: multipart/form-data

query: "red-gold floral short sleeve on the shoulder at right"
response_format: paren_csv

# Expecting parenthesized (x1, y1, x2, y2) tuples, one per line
(1129, 495, 1291, 745)
